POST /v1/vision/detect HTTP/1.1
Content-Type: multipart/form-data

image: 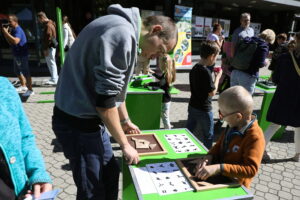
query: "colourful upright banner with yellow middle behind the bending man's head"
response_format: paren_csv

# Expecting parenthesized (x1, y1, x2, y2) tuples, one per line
(174, 5, 192, 69)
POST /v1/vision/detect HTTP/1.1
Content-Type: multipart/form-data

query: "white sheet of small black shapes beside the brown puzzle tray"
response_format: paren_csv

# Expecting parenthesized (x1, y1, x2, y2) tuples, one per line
(165, 134, 201, 153)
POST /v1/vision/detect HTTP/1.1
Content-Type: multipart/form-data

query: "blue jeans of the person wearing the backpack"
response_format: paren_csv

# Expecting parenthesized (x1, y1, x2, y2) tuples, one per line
(230, 69, 257, 95)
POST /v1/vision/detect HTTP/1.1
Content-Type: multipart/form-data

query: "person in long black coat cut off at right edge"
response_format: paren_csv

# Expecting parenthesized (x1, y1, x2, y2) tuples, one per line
(264, 32, 300, 162)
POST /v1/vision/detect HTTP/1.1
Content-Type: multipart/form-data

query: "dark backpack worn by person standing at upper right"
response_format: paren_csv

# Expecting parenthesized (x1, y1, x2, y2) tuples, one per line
(231, 37, 257, 70)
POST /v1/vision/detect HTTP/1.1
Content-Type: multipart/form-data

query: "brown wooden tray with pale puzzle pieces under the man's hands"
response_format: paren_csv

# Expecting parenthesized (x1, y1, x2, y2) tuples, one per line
(126, 133, 168, 156)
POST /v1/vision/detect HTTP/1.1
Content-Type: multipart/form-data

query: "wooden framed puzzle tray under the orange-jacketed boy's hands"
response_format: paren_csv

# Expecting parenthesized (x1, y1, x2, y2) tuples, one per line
(176, 155, 240, 191)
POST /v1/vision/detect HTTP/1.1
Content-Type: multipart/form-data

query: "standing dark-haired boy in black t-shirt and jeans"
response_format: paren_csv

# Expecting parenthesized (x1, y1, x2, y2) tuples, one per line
(186, 41, 222, 149)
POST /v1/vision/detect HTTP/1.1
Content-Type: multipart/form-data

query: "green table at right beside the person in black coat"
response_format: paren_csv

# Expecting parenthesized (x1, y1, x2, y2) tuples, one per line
(256, 85, 285, 139)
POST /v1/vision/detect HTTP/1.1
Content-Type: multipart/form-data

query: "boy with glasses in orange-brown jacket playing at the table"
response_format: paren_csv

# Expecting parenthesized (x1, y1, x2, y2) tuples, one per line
(195, 86, 265, 188)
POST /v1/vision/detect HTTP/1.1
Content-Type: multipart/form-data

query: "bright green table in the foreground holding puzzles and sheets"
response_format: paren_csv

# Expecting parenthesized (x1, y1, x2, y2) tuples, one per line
(122, 129, 253, 200)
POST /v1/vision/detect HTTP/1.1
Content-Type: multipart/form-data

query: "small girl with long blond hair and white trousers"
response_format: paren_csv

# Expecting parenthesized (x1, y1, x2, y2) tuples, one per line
(145, 54, 176, 129)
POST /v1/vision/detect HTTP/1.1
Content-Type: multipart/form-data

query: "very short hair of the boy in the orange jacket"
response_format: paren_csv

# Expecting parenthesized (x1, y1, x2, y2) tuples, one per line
(218, 86, 253, 115)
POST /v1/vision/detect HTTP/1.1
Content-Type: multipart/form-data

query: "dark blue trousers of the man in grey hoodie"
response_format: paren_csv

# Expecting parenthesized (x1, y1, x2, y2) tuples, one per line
(52, 116, 120, 200)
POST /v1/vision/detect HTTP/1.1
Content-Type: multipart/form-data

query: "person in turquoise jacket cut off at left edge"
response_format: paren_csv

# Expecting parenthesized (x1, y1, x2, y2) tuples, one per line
(0, 77, 52, 200)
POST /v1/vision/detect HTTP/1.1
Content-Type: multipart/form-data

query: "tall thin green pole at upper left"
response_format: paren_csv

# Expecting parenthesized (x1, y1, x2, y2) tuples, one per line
(56, 5, 65, 67)
